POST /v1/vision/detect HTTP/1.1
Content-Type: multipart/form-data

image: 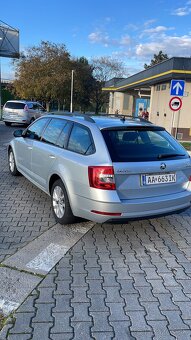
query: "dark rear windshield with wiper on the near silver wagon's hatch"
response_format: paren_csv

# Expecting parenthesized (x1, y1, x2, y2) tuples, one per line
(102, 127, 189, 162)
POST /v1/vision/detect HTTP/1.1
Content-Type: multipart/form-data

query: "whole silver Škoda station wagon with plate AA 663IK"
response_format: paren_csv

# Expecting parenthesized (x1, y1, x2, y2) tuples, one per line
(8, 114, 191, 224)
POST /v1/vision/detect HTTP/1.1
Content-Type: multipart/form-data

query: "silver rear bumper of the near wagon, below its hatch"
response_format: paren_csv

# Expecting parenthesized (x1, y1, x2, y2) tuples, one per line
(73, 191, 191, 223)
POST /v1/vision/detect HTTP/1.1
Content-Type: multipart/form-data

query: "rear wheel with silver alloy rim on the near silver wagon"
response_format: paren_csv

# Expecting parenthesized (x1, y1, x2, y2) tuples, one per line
(51, 179, 76, 224)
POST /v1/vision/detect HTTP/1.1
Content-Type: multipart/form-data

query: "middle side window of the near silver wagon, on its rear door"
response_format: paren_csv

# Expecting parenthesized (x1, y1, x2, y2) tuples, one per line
(42, 118, 67, 145)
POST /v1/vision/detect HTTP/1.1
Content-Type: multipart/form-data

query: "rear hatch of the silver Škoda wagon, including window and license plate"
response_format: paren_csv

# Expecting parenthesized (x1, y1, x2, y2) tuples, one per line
(102, 125, 191, 200)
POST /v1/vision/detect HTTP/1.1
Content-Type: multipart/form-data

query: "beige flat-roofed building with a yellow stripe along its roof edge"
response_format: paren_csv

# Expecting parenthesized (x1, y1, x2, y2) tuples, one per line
(103, 57, 191, 140)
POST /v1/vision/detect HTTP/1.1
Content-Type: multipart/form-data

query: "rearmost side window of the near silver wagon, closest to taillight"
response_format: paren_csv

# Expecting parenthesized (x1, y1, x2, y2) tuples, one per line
(67, 124, 95, 155)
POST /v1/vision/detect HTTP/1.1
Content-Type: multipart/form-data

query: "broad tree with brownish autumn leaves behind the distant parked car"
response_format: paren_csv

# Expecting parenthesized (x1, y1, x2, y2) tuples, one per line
(13, 41, 72, 110)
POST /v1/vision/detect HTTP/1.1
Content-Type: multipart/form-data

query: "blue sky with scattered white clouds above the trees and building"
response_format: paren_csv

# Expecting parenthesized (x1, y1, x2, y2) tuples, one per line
(0, 0, 191, 78)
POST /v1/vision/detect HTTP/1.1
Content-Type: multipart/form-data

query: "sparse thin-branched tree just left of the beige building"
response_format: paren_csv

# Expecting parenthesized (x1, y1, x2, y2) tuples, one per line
(91, 57, 126, 114)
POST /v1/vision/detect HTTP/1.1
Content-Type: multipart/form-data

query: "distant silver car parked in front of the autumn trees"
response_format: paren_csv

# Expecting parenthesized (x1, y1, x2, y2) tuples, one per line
(3, 100, 47, 126)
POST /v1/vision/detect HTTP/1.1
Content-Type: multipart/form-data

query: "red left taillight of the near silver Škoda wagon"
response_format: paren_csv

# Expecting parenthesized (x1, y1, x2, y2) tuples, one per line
(88, 166, 116, 190)
